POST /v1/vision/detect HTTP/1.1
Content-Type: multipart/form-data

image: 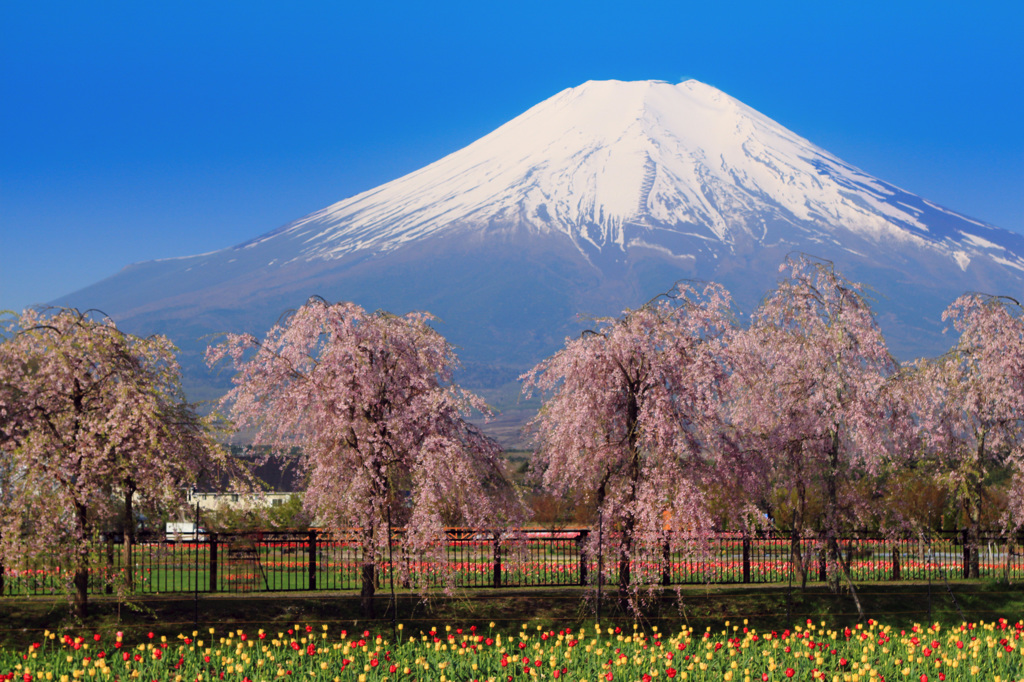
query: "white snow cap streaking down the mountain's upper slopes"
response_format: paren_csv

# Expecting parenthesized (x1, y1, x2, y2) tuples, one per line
(239, 80, 1024, 270)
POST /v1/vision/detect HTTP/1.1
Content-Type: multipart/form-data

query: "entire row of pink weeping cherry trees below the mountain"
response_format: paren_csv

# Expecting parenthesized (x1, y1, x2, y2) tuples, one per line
(0, 250, 1024, 615)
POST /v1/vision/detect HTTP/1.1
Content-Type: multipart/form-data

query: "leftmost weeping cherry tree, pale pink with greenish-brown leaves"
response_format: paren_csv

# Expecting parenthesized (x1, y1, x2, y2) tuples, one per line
(0, 309, 235, 614)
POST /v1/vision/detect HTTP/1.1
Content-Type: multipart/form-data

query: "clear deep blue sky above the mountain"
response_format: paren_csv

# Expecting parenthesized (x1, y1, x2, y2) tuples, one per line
(0, 0, 1024, 309)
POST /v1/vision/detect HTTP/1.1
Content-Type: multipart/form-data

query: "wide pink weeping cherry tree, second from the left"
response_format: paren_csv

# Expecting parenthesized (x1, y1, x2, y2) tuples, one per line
(207, 298, 521, 617)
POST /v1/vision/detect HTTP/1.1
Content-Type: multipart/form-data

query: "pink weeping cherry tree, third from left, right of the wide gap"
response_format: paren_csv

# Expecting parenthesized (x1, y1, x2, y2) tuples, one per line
(521, 278, 731, 605)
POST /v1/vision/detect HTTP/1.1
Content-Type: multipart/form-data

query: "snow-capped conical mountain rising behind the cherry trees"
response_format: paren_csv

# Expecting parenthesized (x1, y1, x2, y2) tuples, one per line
(56, 81, 1024, 411)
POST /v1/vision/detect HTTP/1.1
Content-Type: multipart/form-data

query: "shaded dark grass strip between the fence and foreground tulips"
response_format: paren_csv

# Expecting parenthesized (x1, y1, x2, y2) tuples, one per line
(0, 581, 1024, 650)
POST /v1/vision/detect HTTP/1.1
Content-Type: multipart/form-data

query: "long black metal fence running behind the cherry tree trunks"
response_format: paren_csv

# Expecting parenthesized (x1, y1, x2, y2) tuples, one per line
(0, 528, 1024, 596)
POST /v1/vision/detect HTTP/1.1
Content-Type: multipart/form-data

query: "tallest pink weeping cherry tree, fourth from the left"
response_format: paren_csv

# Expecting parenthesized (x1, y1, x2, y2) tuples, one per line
(729, 256, 896, 587)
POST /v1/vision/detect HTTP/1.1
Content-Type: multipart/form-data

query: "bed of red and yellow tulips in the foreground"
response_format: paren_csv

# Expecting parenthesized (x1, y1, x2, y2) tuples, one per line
(0, 619, 1024, 682)
